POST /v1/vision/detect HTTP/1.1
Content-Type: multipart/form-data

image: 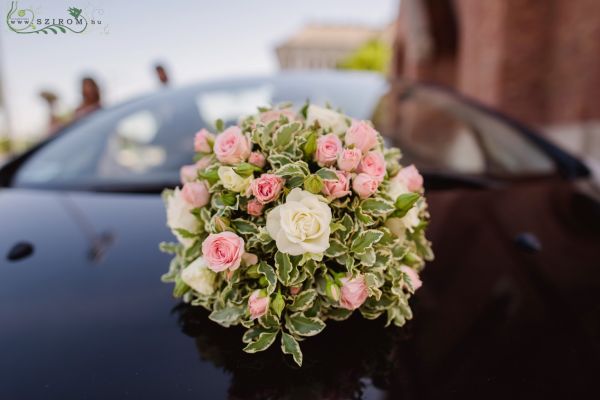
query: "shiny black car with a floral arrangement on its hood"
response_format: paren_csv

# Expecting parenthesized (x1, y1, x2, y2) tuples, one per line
(0, 72, 600, 400)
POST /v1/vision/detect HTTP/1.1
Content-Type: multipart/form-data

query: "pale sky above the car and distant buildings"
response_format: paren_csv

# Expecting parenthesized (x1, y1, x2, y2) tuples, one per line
(0, 0, 399, 137)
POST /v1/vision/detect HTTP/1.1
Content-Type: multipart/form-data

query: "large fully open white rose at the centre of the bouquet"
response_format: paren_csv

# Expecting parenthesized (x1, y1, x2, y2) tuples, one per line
(267, 188, 331, 256)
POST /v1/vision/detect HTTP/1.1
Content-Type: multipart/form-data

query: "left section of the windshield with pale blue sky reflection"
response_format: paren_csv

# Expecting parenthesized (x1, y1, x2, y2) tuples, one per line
(14, 72, 387, 189)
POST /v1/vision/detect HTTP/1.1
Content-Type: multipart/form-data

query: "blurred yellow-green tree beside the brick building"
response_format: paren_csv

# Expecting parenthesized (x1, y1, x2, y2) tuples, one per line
(338, 39, 392, 73)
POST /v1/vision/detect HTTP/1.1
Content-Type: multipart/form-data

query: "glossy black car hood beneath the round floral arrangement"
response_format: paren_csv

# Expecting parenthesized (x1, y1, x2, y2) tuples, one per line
(0, 183, 600, 399)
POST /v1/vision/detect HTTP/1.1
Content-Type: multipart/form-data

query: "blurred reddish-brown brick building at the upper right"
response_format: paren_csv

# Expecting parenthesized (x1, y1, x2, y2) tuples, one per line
(391, 0, 600, 159)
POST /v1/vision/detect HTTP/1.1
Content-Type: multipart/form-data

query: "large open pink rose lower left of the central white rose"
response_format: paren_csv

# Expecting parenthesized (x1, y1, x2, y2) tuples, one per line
(202, 231, 244, 272)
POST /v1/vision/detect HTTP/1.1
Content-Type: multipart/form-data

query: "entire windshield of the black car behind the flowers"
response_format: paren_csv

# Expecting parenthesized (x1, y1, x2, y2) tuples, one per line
(13, 72, 555, 190)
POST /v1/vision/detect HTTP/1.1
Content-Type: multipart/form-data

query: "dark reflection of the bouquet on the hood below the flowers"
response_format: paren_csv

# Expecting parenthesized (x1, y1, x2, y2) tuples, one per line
(174, 303, 411, 399)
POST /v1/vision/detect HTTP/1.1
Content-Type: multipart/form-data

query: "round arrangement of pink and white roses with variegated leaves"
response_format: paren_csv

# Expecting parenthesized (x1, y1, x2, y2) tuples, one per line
(161, 104, 433, 365)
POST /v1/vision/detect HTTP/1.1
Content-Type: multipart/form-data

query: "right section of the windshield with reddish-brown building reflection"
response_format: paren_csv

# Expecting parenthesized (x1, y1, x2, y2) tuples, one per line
(376, 89, 556, 176)
